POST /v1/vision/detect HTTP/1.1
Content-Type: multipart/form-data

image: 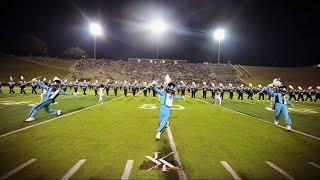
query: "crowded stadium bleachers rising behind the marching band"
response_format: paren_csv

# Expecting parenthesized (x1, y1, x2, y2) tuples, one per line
(72, 59, 242, 84)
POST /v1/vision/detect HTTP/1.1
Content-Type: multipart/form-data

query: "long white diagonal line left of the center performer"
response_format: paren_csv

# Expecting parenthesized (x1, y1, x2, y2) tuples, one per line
(0, 96, 124, 138)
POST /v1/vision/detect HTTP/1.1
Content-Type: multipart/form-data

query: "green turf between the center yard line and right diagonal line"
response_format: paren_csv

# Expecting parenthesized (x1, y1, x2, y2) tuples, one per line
(171, 97, 320, 179)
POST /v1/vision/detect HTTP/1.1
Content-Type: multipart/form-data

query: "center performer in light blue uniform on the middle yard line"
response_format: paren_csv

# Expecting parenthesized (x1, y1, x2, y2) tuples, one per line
(152, 81, 183, 140)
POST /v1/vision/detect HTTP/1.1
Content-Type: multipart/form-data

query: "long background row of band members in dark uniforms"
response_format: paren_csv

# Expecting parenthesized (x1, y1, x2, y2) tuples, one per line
(0, 76, 320, 104)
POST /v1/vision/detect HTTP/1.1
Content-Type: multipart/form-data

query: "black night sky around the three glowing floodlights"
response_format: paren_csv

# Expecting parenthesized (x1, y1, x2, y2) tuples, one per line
(0, 0, 320, 66)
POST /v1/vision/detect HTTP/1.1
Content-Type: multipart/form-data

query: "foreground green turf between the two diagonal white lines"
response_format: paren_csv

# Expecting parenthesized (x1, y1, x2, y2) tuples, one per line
(0, 90, 320, 179)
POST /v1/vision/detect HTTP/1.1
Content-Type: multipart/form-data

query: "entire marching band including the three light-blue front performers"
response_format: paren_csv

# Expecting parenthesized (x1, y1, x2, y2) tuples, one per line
(0, 75, 320, 140)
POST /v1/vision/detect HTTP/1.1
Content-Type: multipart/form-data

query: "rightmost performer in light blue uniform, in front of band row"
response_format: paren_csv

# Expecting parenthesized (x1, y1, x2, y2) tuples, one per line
(267, 81, 292, 131)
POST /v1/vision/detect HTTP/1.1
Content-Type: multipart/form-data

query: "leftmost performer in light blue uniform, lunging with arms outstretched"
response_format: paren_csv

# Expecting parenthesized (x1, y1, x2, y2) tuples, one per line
(25, 77, 73, 122)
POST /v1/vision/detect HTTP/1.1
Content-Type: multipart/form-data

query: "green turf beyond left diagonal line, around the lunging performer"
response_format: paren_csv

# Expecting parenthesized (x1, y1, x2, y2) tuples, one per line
(0, 87, 105, 134)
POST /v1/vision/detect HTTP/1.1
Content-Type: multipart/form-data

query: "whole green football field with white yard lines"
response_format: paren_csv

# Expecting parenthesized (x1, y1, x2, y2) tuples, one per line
(0, 87, 320, 179)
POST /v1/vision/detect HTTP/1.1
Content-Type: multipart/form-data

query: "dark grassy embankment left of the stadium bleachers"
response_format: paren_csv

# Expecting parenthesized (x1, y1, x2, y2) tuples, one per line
(0, 55, 68, 82)
